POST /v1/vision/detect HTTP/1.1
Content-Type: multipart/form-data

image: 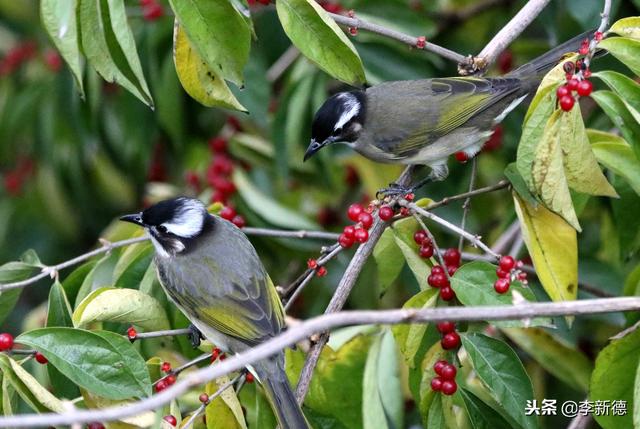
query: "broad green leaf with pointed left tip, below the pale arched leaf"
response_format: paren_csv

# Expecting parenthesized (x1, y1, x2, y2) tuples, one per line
(16, 327, 151, 400)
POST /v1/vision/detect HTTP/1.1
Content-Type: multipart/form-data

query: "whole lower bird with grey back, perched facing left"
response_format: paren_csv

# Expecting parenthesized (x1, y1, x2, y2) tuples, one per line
(120, 197, 310, 429)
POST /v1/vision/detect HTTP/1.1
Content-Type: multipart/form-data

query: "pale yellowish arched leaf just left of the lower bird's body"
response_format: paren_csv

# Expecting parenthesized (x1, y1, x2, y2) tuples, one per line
(73, 287, 170, 331)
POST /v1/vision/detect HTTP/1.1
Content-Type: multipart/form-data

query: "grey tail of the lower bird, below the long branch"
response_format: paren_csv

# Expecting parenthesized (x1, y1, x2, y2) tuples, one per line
(255, 354, 311, 429)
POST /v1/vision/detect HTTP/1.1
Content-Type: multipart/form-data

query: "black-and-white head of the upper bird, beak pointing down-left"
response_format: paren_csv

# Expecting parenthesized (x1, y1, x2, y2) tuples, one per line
(304, 91, 366, 161)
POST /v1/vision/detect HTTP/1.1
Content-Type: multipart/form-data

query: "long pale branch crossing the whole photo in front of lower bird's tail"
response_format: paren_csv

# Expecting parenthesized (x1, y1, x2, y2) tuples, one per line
(5, 298, 640, 427)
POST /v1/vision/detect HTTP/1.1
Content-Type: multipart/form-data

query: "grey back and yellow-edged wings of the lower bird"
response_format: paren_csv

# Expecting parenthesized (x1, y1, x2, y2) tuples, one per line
(158, 219, 284, 345)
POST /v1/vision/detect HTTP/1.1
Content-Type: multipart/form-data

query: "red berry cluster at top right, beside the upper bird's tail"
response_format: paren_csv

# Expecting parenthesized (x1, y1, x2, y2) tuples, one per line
(556, 32, 602, 112)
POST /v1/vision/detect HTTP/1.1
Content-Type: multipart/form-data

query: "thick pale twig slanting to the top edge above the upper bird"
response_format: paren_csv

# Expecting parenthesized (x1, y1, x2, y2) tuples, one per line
(467, 0, 550, 74)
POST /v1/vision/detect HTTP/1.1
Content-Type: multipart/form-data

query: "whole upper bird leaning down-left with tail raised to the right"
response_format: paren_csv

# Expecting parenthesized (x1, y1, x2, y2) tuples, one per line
(304, 32, 593, 195)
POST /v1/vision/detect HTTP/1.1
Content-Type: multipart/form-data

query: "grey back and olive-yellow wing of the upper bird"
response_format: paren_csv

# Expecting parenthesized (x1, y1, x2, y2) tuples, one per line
(374, 77, 521, 158)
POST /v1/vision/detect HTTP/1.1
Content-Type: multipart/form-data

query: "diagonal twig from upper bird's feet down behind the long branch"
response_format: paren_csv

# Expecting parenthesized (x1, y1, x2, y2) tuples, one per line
(296, 166, 413, 404)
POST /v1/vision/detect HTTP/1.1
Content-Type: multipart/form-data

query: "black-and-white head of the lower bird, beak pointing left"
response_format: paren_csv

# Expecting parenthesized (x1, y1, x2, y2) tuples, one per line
(120, 197, 209, 257)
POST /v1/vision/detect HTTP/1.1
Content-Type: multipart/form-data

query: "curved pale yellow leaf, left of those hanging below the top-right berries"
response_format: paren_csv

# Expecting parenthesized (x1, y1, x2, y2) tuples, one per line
(532, 110, 581, 231)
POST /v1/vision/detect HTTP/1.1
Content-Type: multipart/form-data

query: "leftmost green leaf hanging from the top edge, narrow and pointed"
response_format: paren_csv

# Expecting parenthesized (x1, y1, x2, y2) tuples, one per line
(40, 0, 84, 98)
